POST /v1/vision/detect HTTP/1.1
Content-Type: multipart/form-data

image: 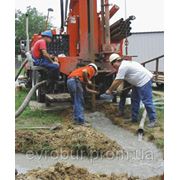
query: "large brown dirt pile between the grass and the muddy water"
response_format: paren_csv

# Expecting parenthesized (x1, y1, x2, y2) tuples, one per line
(16, 125, 123, 157)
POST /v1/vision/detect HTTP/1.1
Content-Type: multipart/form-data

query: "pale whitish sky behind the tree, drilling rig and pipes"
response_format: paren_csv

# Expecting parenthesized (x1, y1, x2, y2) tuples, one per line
(15, 0, 164, 32)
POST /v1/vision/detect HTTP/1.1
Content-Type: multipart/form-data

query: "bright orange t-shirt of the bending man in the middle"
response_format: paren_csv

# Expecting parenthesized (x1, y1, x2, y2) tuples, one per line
(68, 66, 96, 82)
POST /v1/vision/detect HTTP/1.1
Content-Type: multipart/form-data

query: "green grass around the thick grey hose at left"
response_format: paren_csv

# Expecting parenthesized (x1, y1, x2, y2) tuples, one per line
(15, 90, 63, 127)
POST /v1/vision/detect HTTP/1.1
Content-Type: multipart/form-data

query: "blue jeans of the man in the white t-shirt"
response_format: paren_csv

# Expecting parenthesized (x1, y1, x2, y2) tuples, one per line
(131, 80, 156, 122)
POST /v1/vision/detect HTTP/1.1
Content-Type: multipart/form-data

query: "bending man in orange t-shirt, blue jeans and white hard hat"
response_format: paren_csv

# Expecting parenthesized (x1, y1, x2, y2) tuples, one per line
(67, 63, 98, 126)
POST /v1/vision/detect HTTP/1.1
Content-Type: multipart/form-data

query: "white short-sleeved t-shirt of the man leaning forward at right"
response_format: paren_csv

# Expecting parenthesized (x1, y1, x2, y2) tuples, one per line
(116, 61, 153, 87)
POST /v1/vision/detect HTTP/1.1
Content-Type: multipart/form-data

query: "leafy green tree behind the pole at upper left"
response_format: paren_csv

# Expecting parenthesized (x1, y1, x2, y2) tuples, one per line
(15, 6, 52, 54)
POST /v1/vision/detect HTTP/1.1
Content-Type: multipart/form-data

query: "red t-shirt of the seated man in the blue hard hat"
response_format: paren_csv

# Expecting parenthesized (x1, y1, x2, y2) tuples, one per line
(31, 39, 47, 59)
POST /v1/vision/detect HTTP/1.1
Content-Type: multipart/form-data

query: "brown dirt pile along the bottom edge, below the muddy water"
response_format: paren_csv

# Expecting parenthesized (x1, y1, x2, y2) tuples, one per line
(16, 163, 139, 180)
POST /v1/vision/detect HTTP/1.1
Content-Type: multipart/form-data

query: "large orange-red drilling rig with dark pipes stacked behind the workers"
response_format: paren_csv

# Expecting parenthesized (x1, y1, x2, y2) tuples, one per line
(15, 0, 135, 117)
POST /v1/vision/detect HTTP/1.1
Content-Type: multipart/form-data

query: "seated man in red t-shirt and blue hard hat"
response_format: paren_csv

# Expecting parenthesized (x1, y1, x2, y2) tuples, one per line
(31, 30, 59, 80)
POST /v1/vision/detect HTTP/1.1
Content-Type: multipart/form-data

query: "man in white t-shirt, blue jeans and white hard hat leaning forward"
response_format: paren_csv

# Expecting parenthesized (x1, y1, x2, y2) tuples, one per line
(106, 53, 156, 128)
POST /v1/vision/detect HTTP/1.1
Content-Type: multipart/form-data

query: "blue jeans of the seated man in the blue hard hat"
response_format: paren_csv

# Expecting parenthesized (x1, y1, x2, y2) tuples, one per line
(33, 58, 60, 80)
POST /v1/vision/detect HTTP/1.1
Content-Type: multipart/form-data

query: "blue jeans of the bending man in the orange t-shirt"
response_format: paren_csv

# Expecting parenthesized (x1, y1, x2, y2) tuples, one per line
(67, 78, 84, 123)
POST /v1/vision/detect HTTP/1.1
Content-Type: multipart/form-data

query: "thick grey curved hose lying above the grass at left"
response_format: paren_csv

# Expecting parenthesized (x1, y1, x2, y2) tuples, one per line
(15, 80, 47, 118)
